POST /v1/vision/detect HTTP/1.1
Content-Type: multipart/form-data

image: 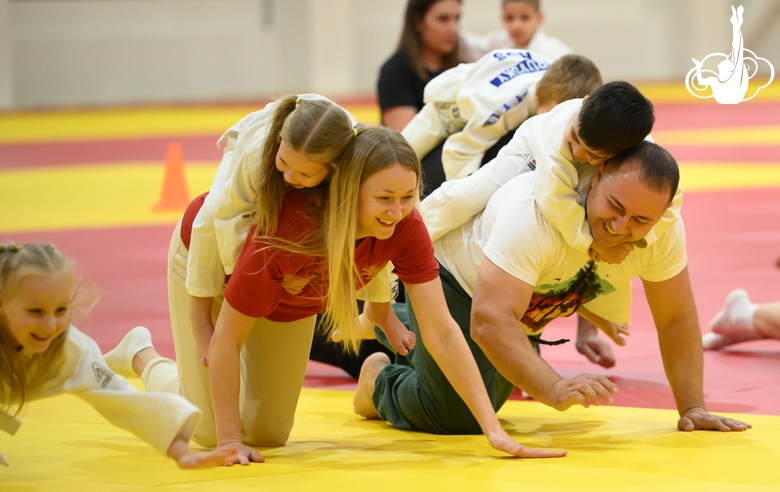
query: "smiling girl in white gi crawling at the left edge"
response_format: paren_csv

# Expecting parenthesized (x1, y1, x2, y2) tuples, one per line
(0, 244, 237, 468)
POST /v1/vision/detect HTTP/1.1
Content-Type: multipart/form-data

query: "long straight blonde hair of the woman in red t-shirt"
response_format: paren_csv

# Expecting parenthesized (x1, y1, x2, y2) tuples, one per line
(323, 127, 422, 352)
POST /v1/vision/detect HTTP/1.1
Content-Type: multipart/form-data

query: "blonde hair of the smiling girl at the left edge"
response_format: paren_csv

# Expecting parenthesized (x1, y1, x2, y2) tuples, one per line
(0, 243, 73, 413)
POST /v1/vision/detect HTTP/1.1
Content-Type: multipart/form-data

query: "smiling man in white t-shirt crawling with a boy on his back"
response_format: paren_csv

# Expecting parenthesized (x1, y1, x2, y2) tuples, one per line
(358, 142, 750, 434)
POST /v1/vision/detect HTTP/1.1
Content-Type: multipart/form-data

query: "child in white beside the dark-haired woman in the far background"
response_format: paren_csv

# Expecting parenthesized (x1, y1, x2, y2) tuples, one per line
(458, 0, 573, 61)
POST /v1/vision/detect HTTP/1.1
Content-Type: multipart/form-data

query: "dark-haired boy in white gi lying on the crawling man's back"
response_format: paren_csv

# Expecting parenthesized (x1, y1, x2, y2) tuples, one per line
(422, 82, 682, 367)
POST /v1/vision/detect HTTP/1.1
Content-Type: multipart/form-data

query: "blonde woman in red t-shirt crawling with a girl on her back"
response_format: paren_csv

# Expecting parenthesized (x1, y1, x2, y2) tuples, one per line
(106, 127, 565, 465)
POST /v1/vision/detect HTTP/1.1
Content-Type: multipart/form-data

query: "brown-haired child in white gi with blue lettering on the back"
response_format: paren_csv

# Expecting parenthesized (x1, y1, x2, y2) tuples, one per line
(401, 50, 602, 186)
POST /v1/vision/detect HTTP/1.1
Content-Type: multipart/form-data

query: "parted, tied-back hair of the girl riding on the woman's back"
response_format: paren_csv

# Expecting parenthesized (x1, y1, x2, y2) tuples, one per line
(254, 95, 356, 235)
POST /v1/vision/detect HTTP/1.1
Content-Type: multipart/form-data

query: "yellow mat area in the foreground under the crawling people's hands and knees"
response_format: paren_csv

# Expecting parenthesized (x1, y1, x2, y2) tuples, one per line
(0, 389, 780, 492)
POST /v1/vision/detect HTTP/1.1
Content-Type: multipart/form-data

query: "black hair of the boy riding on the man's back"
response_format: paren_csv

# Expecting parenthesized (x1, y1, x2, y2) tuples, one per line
(577, 81, 655, 154)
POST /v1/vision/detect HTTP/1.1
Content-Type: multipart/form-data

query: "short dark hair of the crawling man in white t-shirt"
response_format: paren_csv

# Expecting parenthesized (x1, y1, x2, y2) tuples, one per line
(604, 140, 680, 202)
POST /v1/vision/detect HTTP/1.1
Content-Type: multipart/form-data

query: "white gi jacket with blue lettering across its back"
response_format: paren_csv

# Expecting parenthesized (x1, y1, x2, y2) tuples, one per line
(401, 50, 552, 180)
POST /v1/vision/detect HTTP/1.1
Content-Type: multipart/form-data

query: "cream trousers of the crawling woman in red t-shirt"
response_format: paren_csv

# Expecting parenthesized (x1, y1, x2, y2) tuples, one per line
(141, 221, 316, 447)
